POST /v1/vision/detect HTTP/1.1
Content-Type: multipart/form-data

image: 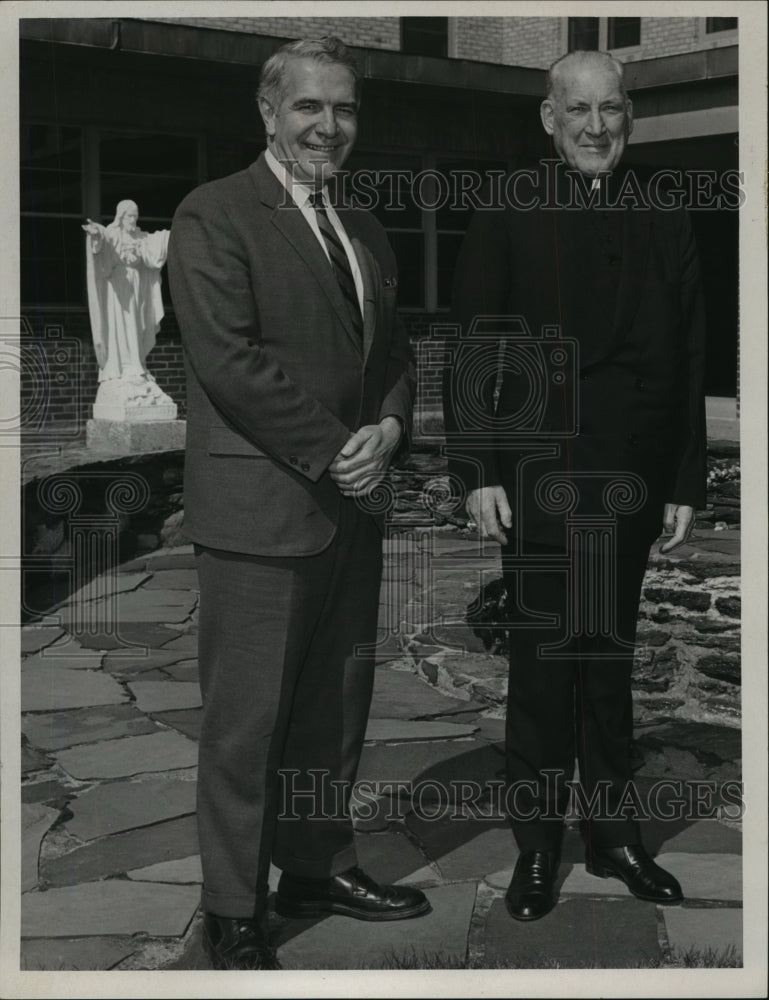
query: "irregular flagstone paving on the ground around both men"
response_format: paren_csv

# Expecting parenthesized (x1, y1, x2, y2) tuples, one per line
(15, 544, 742, 970)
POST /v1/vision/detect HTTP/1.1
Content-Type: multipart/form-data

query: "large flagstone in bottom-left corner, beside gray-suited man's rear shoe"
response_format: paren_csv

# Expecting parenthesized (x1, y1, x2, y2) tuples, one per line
(21, 879, 200, 937)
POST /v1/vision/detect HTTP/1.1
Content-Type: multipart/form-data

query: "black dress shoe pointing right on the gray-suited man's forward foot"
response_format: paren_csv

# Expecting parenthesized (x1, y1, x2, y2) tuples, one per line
(275, 868, 430, 920)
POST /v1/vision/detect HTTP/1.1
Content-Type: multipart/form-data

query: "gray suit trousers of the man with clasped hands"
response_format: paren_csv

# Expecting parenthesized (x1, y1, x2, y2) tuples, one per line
(196, 498, 382, 917)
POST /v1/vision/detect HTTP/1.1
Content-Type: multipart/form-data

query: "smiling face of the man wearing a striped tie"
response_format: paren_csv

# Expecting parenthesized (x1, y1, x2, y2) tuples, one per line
(259, 58, 358, 188)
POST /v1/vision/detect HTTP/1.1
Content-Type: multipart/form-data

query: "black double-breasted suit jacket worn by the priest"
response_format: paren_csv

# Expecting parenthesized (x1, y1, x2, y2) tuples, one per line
(443, 167, 706, 546)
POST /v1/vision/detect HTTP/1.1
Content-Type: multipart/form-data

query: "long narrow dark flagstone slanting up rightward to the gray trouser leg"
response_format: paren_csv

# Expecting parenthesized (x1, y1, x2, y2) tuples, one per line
(40, 816, 200, 888)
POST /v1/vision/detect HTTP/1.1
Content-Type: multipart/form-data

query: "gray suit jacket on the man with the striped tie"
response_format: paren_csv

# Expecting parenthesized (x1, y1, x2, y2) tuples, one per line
(168, 156, 414, 556)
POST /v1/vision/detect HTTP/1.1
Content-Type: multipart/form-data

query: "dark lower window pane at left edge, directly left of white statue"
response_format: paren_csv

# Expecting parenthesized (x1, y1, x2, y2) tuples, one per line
(20, 216, 88, 307)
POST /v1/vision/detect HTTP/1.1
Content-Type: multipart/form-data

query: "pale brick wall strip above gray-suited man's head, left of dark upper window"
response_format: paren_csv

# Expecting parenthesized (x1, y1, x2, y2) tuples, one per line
(152, 17, 400, 49)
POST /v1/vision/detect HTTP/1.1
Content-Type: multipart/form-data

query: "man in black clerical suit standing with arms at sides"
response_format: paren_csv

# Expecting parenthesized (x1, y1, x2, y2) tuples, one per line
(444, 52, 705, 920)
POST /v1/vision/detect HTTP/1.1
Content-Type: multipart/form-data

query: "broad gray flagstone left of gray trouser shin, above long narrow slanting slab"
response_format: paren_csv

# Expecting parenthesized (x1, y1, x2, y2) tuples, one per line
(66, 778, 195, 840)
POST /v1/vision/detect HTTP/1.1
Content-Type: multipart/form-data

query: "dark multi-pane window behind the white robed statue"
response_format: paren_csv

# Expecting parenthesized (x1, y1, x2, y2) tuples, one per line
(20, 123, 198, 306)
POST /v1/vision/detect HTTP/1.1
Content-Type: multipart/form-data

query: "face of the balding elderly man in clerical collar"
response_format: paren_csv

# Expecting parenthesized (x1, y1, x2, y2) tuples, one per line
(540, 60, 633, 177)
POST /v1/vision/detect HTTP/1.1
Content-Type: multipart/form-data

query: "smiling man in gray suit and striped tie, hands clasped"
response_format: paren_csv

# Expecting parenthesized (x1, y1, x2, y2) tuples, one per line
(168, 38, 429, 968)
